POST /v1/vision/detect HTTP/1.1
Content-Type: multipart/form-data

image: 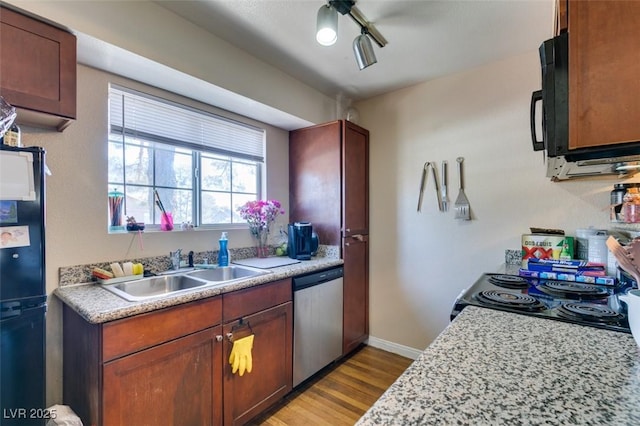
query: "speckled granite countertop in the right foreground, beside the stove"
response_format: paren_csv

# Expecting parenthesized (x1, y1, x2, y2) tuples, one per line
(356, 306, 640, 426)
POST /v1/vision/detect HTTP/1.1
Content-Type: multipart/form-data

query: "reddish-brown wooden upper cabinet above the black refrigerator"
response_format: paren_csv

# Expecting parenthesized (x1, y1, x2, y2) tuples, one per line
(0, 7, 76, 130)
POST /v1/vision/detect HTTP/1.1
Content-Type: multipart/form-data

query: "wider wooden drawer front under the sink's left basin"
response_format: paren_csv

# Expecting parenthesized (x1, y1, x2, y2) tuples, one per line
(102, 297, 222, 362)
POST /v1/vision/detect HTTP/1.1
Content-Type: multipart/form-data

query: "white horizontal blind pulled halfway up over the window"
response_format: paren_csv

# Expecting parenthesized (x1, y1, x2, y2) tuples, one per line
(109, 85, 265, 162)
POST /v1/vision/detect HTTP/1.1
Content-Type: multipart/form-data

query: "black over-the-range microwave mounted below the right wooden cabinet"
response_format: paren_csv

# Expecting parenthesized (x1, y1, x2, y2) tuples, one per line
(530, 33, 640, 180)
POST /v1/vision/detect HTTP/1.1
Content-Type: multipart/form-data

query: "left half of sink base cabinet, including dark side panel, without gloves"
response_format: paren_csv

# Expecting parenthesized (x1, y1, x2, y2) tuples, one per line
(63, 297, 223, 426)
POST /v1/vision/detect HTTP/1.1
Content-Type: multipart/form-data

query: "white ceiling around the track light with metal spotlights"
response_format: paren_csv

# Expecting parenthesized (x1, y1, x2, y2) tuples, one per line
(157, 0, 555, 101)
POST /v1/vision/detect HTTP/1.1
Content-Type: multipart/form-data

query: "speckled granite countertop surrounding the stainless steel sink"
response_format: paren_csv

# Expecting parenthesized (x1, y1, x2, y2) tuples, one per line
(54, 257, 343, 324)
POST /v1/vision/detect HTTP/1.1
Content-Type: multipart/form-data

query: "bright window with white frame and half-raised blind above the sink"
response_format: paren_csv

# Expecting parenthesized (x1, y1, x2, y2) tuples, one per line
(107, 86, 265, 229)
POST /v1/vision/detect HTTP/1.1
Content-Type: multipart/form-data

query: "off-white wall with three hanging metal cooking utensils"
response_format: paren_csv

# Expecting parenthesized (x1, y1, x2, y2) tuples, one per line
(356, 52, 636, 349)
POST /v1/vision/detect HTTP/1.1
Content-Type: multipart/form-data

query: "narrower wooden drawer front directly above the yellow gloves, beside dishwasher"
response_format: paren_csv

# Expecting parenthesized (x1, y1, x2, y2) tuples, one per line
(222, 278, 292, 322)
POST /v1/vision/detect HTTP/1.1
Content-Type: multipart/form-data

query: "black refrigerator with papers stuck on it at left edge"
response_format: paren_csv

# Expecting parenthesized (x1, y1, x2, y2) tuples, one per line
(0, 145, 47, 426)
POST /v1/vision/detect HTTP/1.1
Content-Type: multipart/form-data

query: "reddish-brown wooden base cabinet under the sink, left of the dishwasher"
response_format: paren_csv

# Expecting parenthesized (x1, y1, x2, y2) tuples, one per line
(63, 279, 293, 426)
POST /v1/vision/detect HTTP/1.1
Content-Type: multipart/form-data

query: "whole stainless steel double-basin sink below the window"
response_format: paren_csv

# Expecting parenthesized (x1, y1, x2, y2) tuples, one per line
(103, 265, 270, 302)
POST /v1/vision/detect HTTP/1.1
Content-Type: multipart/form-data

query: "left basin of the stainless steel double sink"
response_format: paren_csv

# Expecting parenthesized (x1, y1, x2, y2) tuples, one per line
(103, 274, 209, 302)
